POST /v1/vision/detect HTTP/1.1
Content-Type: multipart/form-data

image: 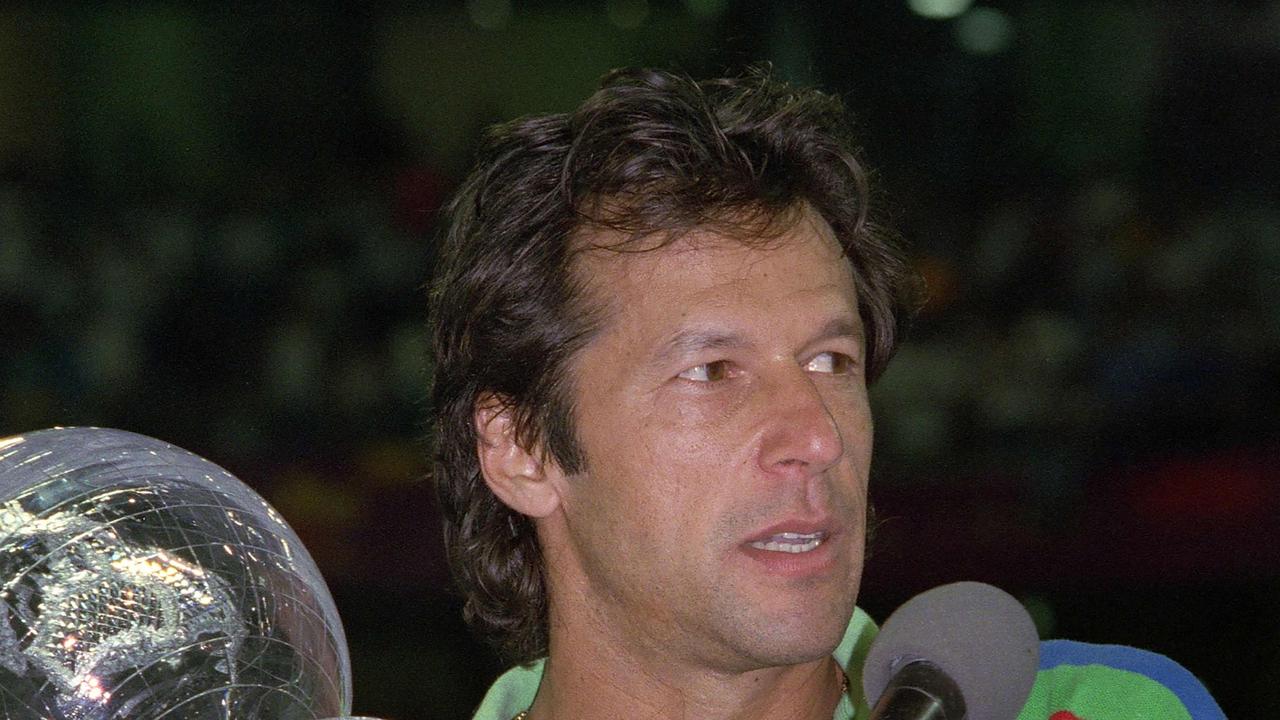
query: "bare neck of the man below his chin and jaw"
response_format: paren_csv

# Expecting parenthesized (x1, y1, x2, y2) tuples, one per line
(527, 638, 844, 720)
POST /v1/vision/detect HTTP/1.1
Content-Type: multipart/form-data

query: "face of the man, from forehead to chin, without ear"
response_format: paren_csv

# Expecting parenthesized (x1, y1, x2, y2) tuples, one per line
(541, 213, 872, 671)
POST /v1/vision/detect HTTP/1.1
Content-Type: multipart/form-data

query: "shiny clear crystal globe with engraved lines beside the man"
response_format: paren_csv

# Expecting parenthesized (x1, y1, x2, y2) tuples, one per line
(0, 428, 351, 720)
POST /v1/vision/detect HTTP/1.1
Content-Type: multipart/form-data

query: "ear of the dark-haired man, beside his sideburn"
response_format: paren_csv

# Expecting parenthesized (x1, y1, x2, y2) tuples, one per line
(474, 393, 559, 518)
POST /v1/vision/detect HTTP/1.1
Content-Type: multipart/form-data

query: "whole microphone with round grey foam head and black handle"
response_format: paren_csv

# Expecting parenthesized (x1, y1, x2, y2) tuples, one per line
(863, 582, 1039, 720)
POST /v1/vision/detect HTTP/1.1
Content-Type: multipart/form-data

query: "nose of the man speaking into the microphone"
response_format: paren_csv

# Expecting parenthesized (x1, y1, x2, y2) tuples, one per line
(760, 368, 845, 475)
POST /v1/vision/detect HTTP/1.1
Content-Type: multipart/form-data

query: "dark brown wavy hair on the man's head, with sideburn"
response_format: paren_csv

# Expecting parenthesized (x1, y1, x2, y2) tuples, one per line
(430, 69, 913, 662)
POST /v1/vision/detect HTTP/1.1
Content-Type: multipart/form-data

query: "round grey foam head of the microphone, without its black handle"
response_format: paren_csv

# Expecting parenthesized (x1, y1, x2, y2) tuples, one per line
(863, 582, 1039, 720)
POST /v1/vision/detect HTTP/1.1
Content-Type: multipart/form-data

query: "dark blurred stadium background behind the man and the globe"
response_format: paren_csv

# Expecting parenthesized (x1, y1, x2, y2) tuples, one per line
(0, 0, 1280, 720)
